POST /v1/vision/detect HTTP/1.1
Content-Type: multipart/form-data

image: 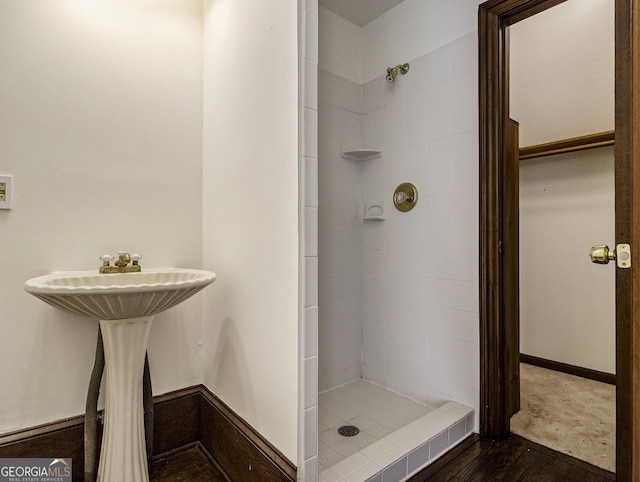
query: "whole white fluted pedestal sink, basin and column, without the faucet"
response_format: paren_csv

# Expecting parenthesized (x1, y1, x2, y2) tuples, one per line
(25, 268, 216, 482)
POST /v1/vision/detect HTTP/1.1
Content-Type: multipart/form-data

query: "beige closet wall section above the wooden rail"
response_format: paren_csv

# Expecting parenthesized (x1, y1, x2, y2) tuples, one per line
(510, 0, 614, 147)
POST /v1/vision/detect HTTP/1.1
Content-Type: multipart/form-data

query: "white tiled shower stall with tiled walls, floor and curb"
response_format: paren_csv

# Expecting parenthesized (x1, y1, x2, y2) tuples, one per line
(301, 0, 479, 481)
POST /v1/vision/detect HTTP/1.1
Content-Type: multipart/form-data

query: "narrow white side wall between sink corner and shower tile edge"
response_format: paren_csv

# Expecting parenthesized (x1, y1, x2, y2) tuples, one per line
(203, 0, 298, 461)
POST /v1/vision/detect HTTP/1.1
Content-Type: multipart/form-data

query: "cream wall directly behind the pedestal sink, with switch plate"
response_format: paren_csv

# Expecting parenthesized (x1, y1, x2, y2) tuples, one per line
(0, 0, 202, 432)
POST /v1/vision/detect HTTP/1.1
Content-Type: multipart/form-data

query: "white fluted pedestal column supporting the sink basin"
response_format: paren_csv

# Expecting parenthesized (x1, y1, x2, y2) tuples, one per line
(98, 316, 153, 482)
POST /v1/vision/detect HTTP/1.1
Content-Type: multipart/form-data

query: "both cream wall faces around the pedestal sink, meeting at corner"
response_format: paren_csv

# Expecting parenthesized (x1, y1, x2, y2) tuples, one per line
(0, 0, 298, 461)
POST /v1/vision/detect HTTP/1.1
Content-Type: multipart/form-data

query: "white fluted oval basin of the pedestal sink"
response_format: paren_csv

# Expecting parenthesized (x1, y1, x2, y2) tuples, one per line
(24, 268, 216, 320)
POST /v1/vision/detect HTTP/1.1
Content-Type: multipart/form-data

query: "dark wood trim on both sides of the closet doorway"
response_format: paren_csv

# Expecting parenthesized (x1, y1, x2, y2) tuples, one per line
(478, 0, 640, 481)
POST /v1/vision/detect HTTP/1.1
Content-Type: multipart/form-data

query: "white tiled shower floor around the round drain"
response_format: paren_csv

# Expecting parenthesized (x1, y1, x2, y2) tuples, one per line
(318, 380, 432, 472)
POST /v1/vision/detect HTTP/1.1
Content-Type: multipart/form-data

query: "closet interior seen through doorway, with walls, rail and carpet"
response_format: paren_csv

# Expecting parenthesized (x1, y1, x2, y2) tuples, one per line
(508, 0, 615, 472)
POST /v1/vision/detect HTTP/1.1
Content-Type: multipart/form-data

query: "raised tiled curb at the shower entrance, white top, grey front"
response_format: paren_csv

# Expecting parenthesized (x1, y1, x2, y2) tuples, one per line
(320, 402, 474, 482)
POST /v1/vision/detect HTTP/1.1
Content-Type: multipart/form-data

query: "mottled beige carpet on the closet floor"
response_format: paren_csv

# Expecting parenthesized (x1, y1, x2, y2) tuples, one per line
(511, 364, 616, 472)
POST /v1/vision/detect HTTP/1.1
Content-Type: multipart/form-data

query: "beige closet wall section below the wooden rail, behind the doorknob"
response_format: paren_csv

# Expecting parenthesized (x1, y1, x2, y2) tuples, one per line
(520, 147, 615, 373)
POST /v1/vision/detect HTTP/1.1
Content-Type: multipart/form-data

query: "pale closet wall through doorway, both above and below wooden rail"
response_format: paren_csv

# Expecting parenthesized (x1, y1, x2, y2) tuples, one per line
(510, 0, 615, 373)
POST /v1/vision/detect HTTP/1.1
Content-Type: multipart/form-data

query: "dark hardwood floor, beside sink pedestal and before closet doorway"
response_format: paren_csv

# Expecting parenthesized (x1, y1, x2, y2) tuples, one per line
(151, 435, 616, 482)
